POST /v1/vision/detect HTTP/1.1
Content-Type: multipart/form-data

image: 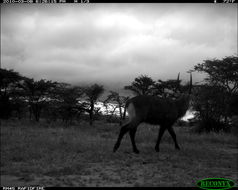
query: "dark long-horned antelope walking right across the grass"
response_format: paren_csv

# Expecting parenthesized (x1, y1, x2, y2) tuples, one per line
(113, 73, 192, 154)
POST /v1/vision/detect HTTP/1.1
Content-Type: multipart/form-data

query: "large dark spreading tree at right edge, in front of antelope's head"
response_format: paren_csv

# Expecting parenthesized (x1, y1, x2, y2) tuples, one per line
(194, 56, 238, 131)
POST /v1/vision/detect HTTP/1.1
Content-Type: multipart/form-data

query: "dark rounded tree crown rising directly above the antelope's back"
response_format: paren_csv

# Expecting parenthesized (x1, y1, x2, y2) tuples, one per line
(124, 75, 155, 95)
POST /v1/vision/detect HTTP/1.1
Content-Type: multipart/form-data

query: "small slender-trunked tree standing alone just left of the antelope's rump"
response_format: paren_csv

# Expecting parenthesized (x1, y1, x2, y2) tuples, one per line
(84, 84, 104, 125)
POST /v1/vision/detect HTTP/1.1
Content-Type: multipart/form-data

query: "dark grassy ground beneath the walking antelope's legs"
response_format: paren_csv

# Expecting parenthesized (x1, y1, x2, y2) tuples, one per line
(1, 121, 238, 187)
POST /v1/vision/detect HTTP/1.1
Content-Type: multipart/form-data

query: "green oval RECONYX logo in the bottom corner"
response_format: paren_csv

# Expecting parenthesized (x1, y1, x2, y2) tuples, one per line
(197, 178, 235, 190)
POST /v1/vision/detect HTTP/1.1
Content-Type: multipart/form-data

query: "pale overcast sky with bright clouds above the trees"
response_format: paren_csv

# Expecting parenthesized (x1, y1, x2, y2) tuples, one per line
(1, 4, 237, 92)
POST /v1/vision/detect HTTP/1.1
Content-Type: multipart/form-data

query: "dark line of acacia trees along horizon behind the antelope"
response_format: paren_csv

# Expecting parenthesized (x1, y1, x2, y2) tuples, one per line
(0, 56, 238, 132)
